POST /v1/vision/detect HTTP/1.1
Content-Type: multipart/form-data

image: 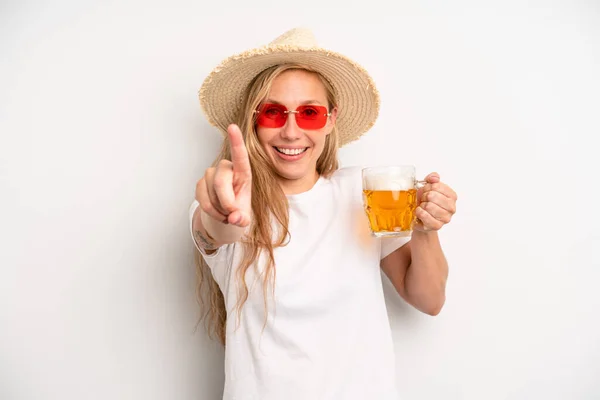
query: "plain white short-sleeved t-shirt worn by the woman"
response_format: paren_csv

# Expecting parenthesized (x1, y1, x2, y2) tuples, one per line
(190, 168, 409, 400)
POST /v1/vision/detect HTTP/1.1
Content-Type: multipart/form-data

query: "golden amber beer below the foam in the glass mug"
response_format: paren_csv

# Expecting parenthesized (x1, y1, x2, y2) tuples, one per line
(363, 189, 417, 236)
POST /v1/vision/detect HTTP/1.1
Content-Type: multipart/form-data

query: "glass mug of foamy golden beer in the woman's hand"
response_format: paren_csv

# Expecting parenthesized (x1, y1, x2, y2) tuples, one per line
(362, 165, 426, 237)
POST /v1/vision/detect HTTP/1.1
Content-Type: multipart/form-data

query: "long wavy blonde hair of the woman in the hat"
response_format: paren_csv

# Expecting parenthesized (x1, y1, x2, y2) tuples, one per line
(195, 64, 339, 345)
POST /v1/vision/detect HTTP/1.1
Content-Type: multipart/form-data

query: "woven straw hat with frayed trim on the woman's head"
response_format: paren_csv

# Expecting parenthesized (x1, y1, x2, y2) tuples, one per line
(199, 28, 379, 146)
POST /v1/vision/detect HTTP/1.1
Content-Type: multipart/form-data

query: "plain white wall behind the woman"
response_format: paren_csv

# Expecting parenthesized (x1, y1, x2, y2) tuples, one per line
(0, 0, 600, 400)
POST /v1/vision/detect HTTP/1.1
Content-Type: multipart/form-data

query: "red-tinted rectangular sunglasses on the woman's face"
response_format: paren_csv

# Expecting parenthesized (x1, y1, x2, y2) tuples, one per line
(256, 103, 331, 130)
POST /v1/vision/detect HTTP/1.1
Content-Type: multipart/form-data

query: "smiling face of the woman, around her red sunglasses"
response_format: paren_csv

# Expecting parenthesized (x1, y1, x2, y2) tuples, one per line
(257, 70, 337, 194)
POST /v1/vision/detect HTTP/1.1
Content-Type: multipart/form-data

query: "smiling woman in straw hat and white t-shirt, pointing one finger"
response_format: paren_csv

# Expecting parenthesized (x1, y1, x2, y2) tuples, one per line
(190, 29, 456, 400)
